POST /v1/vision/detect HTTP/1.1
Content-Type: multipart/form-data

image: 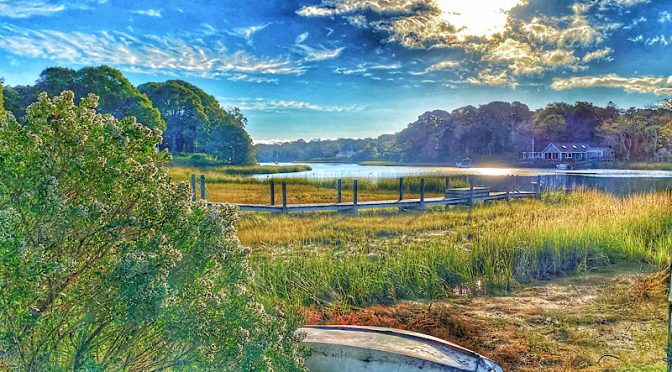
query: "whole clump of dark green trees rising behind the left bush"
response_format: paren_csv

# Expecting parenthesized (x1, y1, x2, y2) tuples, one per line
(0, 66, 256, 164)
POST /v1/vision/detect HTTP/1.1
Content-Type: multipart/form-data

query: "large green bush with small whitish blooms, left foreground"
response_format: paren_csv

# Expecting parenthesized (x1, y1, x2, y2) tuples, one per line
(0, 91, 301, 371)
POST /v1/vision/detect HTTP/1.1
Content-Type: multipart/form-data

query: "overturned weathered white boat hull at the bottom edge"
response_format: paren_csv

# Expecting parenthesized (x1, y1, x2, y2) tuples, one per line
(297, 325, 502, 372)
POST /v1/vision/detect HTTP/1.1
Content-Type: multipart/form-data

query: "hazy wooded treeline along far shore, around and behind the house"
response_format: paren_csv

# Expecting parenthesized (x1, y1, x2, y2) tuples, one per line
(257, 101, 672, 163)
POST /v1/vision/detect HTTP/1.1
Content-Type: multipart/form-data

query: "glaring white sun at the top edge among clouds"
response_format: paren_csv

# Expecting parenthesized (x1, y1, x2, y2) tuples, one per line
(436, 0, 526, 39)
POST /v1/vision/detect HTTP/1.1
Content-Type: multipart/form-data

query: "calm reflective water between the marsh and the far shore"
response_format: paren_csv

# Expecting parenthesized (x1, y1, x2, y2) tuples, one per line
(255, 163, 672, 195)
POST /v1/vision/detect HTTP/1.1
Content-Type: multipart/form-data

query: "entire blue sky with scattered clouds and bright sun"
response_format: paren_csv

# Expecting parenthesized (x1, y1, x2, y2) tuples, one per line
(0, 0, 672, 143)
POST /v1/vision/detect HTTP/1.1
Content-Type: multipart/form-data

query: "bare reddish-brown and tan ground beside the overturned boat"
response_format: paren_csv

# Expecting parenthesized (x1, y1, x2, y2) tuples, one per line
(307, 266, 667, 371)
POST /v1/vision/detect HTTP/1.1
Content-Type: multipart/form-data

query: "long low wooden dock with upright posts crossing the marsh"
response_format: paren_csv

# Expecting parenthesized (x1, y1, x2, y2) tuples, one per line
(197, 175, 541, 213)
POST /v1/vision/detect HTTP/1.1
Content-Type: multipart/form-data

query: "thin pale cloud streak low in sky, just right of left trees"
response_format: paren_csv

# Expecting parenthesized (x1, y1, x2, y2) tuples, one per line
(218, 97, 364, 112)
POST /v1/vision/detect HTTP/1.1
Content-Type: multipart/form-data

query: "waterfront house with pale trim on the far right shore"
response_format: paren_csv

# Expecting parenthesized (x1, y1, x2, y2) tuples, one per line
(521, 142, 614, 162)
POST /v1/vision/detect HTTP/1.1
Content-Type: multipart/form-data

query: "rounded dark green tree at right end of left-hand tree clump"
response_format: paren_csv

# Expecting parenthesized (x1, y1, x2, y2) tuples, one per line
(138, 80, 256, 164)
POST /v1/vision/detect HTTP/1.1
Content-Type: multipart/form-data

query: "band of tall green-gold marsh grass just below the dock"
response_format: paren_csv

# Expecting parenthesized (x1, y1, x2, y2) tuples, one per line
(238, 190, 672, 307)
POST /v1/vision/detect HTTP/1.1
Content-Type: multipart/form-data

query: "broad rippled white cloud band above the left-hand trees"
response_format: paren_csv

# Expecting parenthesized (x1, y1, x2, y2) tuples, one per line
(0, 25, 305, 78)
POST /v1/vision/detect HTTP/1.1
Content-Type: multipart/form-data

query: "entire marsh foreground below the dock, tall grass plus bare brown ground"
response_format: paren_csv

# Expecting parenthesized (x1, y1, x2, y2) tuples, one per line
(237, 190, 672, 371)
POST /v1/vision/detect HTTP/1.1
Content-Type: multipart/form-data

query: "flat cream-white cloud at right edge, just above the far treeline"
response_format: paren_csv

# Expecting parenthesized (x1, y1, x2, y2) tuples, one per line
(551, 74, 672, 96)
